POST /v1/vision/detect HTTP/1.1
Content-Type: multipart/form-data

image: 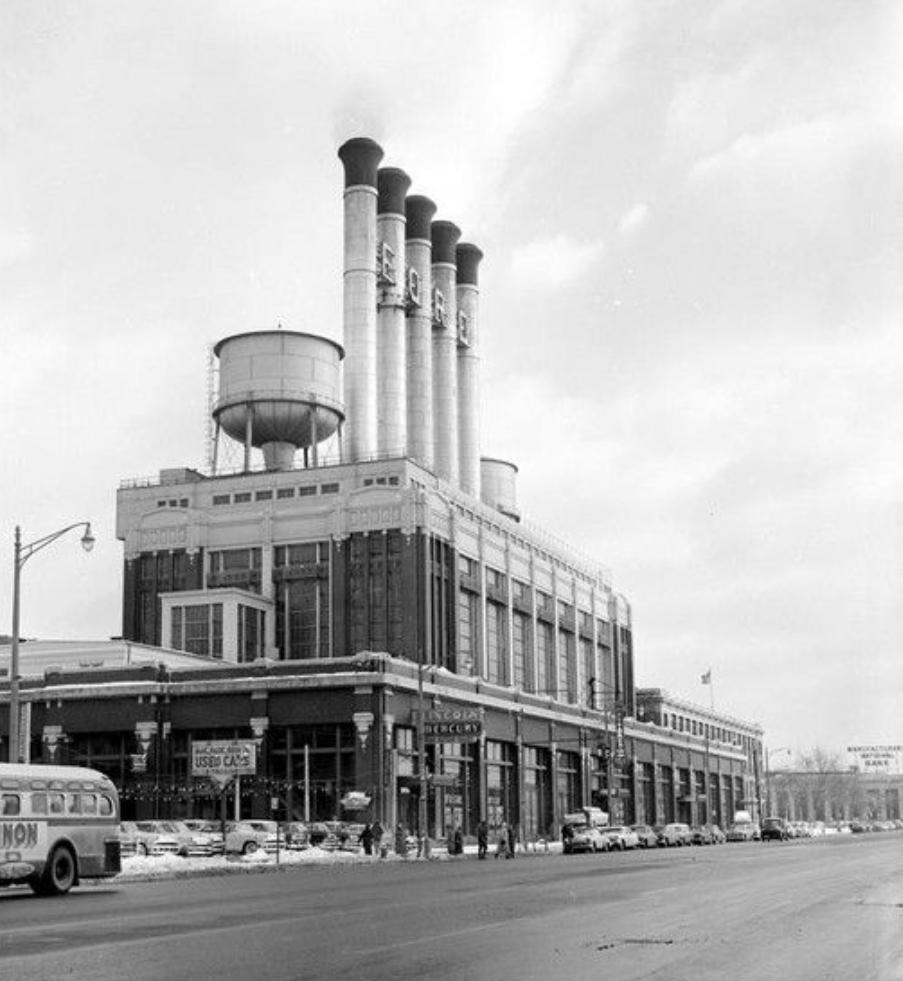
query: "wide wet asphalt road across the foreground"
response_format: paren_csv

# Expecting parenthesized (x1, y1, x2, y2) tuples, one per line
(0, 833, 903, 981)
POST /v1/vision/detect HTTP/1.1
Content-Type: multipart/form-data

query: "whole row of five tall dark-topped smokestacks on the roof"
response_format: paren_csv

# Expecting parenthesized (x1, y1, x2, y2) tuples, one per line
(339, 138, 483, 497)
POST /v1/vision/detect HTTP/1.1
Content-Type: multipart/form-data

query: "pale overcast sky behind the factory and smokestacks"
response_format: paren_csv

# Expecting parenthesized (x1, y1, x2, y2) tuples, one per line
(0, 0, 903, 762)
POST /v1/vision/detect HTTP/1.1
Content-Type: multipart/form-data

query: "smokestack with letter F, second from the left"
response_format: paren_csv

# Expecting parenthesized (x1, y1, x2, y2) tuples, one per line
(376, 167, 411, 456)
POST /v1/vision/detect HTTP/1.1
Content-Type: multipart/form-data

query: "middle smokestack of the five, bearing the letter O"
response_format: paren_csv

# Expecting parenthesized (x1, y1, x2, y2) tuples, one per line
(405, 194, 436, 470)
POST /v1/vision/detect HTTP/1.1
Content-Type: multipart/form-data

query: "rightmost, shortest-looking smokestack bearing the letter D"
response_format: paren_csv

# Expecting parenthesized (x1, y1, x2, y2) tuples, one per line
(455, 243, 483, 498)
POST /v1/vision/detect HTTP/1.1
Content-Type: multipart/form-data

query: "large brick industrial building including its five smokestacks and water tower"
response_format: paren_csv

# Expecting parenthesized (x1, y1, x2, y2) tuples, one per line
(0, 139, 762, 840)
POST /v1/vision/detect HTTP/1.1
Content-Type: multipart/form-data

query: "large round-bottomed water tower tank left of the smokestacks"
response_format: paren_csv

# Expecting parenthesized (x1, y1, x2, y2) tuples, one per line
(213, 330, 345, 470)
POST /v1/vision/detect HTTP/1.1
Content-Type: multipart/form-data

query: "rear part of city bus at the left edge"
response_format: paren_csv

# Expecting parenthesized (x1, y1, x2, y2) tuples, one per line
(0, 763, 120, 896)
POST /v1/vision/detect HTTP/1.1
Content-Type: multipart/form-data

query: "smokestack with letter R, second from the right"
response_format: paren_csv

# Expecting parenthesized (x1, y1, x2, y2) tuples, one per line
(431, 221, 461, 484)
